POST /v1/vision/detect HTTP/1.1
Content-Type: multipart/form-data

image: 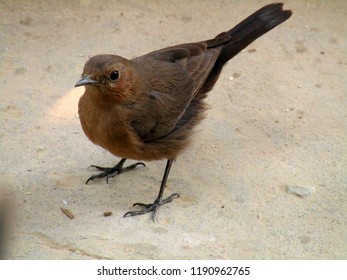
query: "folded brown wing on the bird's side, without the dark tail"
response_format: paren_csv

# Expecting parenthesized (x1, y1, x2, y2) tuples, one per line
(131, 39, 228, 141)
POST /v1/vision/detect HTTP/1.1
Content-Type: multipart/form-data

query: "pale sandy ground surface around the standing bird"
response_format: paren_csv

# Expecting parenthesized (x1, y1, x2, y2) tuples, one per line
(0, 0, 347, 259)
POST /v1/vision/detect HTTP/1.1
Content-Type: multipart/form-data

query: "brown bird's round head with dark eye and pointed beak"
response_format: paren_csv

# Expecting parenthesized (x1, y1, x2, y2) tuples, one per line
(75, 54, 138, 103)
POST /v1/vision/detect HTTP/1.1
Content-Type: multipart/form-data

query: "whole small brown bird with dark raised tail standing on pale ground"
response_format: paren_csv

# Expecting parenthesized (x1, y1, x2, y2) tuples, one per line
(75, 3, 292, 221)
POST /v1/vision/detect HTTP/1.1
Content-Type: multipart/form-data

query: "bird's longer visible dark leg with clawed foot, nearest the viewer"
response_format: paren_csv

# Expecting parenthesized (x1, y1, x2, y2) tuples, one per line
(123, 159, 180, 222)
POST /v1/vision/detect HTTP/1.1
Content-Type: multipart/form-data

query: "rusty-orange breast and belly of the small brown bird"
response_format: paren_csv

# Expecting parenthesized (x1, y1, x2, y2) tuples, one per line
(78, 88, 191, 161)
